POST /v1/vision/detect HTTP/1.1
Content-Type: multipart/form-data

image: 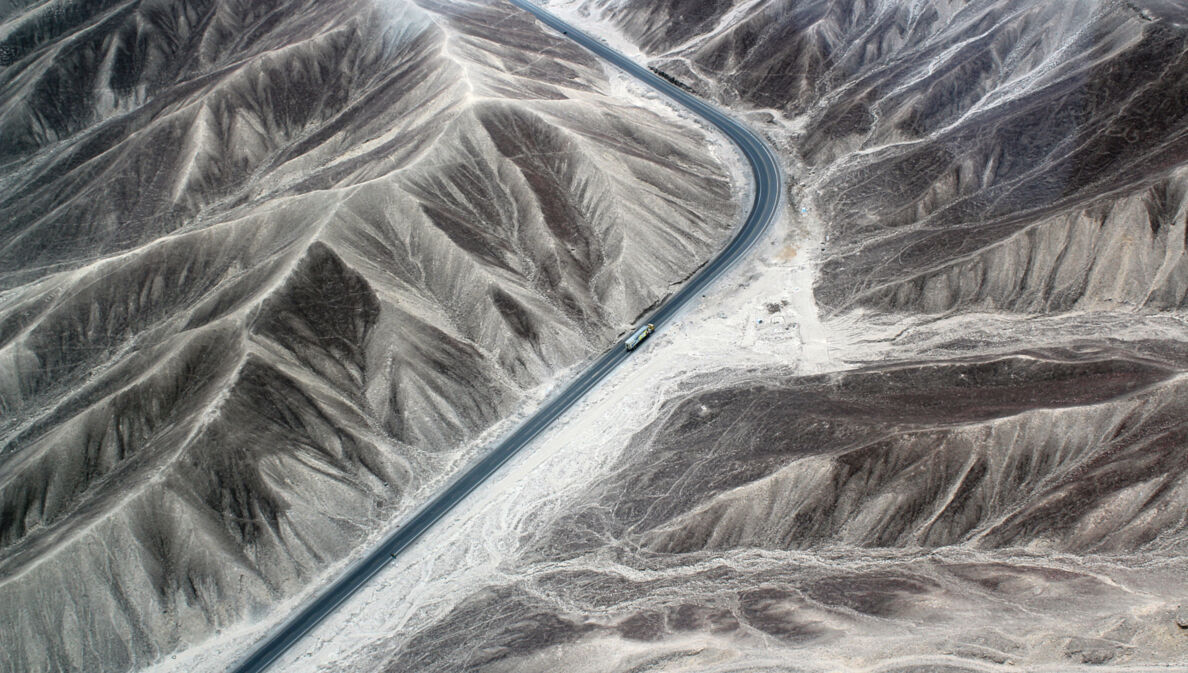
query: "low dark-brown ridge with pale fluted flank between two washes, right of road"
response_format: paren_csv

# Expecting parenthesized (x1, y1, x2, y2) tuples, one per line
(548, 353, 1188, 553)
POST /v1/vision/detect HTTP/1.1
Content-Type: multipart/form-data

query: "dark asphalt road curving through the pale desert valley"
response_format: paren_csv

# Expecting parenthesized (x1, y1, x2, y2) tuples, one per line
(232, 0, 784, 673)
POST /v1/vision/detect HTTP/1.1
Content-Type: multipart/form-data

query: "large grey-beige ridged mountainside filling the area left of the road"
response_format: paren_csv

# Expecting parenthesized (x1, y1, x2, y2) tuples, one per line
(0, 0, 734, 671)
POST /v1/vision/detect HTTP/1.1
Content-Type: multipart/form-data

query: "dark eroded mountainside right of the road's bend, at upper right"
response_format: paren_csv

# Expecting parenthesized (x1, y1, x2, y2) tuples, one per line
(556, 0, 1188, 313)
